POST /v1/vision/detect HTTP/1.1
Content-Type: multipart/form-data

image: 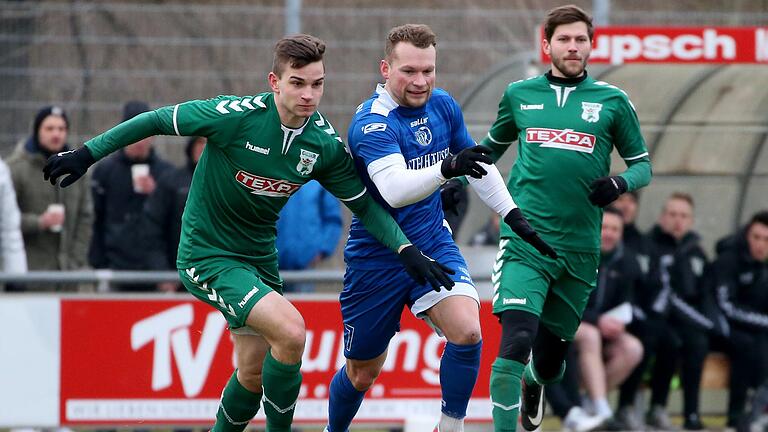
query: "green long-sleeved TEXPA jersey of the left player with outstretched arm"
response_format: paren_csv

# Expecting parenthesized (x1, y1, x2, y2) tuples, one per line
(86, 93, 408, 268)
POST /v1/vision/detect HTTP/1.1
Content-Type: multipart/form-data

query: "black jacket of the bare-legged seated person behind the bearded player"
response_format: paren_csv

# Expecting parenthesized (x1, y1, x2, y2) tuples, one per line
(582, 244, 643, 324)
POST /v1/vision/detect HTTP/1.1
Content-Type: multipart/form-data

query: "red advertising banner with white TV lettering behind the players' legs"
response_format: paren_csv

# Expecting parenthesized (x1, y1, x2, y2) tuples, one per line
(60, 299, 500, 425)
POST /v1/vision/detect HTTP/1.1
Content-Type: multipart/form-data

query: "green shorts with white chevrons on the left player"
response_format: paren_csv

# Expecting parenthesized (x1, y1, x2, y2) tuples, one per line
(179, 257, 283, 330)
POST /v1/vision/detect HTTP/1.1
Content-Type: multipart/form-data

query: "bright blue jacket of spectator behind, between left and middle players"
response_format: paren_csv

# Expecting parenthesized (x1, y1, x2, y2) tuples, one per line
(276, 181, 342, 292)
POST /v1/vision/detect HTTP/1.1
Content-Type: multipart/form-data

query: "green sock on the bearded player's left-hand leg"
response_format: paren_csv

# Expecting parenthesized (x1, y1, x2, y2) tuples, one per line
(491, 357, 525, 432)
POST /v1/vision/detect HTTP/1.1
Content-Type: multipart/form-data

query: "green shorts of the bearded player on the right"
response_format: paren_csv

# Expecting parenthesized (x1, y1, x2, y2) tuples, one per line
(492, 236, 600, 341)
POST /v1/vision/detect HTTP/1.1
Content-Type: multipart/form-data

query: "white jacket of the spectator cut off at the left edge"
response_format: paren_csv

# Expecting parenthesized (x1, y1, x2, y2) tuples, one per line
(0, 159, 27, 291)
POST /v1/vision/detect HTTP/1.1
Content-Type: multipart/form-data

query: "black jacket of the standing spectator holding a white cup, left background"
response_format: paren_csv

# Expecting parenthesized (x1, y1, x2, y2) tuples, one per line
(88, 150, 173, 270)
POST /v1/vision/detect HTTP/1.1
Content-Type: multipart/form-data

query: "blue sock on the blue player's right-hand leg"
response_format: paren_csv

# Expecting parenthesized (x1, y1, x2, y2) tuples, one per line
(440, 341, 483, 419)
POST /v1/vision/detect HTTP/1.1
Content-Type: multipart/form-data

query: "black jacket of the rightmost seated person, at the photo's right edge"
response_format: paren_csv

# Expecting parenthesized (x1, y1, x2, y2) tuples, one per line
(712, 230, 768, 332)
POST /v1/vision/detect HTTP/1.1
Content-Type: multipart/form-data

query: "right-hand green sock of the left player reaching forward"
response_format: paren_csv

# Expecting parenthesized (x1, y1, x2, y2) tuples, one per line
(261, 351, 301, 432)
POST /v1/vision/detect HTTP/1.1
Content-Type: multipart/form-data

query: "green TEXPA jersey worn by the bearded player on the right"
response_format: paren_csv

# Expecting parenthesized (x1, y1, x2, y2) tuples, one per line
(483, 74, 651, 252)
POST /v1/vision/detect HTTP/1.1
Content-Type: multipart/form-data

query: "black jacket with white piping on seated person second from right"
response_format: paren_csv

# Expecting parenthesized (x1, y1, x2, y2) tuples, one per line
(643, 225, 715, 330)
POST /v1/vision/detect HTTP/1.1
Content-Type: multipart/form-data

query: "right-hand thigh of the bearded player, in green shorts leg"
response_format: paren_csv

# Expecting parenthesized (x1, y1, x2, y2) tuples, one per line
(541, 273, 594, 341)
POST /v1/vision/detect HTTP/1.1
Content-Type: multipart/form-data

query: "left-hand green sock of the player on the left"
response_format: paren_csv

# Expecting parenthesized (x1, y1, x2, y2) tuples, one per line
(211, 369, 261, 432)
